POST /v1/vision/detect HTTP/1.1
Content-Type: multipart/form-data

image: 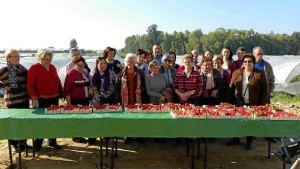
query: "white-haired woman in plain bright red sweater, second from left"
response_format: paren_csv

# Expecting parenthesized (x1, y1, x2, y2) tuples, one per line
(27, 49, 62, 151)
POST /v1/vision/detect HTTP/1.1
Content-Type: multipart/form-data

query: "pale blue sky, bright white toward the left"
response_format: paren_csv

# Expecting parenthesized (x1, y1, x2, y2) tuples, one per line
(0, 0, 300, 50)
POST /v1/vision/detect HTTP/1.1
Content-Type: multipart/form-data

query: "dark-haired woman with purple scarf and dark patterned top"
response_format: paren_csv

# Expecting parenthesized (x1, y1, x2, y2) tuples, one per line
(91, 57, 116, 104)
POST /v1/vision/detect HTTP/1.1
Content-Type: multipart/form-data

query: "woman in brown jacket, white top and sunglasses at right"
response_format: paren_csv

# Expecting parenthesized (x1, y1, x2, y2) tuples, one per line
(227, 54, 269, 150)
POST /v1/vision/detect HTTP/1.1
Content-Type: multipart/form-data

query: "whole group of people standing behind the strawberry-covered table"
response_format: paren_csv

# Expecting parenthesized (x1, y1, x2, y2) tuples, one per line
(0, 45, 274, 150)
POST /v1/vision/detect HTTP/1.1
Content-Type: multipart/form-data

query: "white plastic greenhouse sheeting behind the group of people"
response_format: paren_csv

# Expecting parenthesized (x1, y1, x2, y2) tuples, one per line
(0, 53, 300, 94)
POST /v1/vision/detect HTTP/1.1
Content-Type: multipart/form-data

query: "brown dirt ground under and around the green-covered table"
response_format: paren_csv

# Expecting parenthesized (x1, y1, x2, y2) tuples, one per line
(0, 100, 300, 169)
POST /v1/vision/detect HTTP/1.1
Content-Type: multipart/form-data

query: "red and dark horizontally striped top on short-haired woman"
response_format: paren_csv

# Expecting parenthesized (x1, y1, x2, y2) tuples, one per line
(173, 71, 203, 98)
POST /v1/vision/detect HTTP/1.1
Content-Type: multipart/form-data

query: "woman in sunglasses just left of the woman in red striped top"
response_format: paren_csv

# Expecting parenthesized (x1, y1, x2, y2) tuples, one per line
(159, 54, 177, 86)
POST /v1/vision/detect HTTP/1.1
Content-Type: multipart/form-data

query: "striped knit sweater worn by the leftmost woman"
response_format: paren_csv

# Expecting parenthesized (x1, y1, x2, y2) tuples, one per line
(0, 66, 29, 108)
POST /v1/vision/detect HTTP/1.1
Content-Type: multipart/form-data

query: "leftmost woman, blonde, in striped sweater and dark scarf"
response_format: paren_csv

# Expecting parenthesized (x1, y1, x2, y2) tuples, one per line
(0, 49, 29, 152)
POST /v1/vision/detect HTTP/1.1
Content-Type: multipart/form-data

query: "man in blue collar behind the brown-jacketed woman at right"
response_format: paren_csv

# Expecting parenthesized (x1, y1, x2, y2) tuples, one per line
(253, 46, 277, 143)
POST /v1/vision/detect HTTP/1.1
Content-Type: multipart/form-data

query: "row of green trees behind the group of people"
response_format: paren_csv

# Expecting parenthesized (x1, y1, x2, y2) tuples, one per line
(122, 24, 300, 55)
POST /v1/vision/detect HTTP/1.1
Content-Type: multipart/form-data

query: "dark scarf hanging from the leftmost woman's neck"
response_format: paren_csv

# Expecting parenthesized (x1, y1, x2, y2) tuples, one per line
(7, 62, 26, 88)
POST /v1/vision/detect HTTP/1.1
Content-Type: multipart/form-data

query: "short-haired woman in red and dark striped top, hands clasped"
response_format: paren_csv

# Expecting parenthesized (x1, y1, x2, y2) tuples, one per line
(173, 54, 203, 105)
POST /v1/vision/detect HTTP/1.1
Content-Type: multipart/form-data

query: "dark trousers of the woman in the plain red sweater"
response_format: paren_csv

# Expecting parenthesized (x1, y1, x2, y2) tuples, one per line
(33, 97, 58, 148)
